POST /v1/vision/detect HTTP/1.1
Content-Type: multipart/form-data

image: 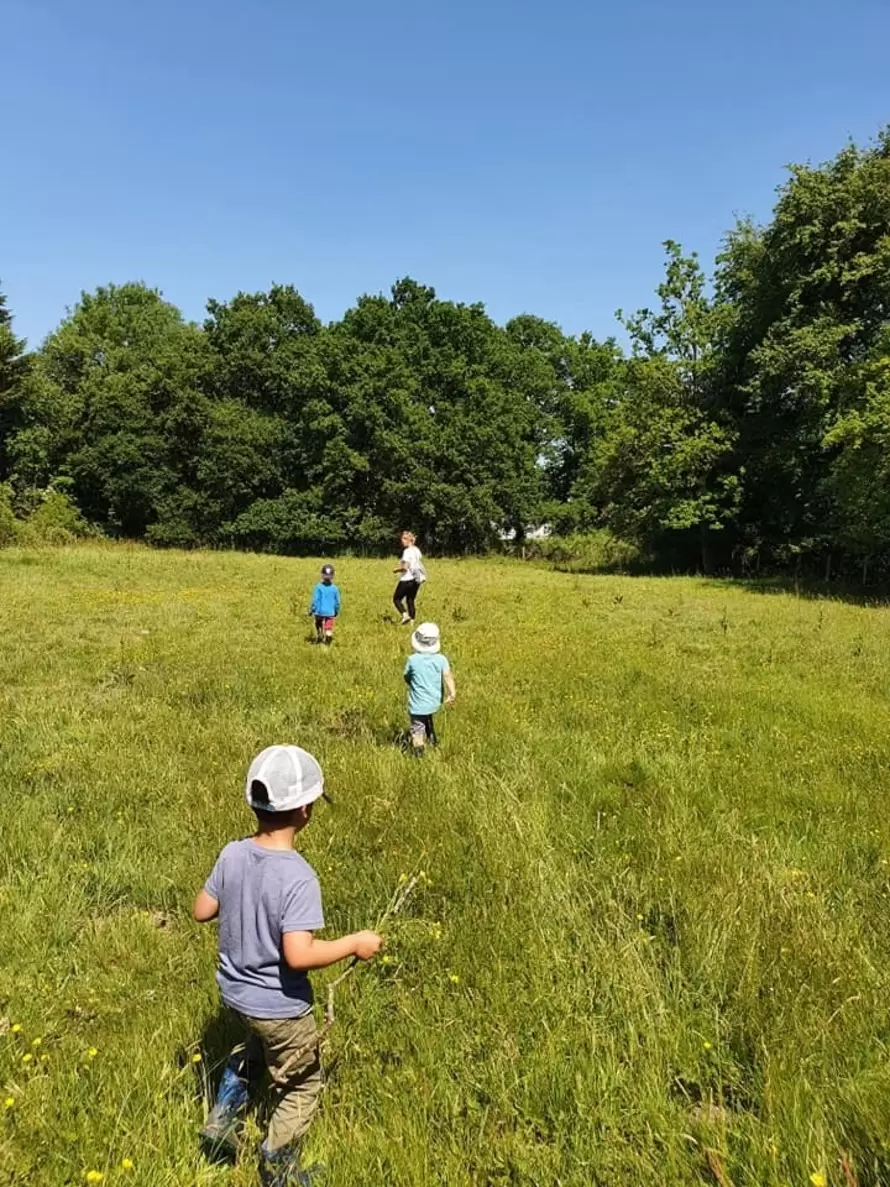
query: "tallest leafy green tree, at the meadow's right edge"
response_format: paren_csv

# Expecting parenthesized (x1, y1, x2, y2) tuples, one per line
(717, 132, 890, 560)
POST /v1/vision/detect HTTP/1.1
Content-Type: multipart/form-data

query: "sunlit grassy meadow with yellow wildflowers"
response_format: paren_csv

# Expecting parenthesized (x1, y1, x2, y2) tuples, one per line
(0, 546, 890, 1187)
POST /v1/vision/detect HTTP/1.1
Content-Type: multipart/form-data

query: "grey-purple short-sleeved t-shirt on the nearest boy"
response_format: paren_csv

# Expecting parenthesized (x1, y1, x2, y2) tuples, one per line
(204, 837, 324, 1018)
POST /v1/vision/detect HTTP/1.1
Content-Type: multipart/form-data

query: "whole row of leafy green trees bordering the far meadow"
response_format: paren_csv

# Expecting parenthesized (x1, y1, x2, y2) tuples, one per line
(0, 128, 890, 576)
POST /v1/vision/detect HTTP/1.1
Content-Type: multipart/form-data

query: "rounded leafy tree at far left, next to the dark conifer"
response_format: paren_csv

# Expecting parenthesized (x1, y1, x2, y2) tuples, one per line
(11, 284, 208, 537)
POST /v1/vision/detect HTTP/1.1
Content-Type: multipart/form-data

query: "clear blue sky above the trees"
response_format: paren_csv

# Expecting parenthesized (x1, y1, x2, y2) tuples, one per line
(0, 0, 890, 344)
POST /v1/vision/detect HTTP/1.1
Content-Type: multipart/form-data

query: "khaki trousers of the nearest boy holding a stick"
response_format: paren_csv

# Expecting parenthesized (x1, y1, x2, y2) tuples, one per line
(237, 1013, 324, 1153)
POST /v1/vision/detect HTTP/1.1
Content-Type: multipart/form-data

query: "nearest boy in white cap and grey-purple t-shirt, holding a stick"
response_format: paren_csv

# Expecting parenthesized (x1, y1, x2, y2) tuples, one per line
(195, 745, 382, 1187)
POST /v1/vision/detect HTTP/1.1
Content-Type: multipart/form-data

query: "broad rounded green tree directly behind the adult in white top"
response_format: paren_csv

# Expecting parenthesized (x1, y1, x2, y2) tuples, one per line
(329, 279, 543, 550)
